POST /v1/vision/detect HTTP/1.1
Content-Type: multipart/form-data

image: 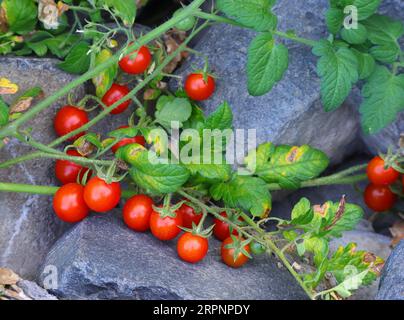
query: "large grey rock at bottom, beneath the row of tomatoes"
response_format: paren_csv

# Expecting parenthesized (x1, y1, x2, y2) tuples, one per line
(39, 213, 306, 300)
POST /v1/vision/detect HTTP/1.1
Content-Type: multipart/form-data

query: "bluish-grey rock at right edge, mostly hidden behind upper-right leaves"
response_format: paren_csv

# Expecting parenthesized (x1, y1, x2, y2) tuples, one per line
(362, 0, 404, 154)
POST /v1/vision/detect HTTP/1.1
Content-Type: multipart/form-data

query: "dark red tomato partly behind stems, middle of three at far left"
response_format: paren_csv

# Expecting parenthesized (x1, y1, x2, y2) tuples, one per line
(55, 149, 91, 184)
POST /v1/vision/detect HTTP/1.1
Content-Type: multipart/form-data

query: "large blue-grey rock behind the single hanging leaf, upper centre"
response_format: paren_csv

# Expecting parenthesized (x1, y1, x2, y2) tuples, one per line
(171, 0, 359, 162)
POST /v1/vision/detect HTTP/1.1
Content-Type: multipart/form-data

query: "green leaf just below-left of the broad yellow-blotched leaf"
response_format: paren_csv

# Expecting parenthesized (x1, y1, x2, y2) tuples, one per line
(210, 175, 272, 217)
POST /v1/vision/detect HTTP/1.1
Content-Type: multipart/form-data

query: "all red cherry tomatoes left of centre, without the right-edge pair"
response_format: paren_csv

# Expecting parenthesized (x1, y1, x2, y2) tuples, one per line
(53, 42, 258, 267)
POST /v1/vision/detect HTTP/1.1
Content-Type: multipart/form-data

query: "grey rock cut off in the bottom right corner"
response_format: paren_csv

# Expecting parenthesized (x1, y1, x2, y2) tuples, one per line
(376, 240, 404, 300)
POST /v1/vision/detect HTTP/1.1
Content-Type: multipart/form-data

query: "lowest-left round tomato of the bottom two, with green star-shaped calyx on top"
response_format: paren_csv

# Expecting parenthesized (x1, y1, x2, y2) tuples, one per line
(177, 232, 209, 263)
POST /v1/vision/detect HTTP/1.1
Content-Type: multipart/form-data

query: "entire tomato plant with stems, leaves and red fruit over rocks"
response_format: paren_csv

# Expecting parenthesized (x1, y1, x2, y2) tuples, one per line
(0, 0, 404, 299)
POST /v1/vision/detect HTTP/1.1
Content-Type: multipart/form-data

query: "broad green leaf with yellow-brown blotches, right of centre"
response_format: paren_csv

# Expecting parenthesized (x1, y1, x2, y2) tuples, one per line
(257, 145, 329, 189)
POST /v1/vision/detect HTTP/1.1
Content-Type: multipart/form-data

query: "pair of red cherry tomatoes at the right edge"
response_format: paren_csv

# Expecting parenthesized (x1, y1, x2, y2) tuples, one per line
(364, 156, 404, 212)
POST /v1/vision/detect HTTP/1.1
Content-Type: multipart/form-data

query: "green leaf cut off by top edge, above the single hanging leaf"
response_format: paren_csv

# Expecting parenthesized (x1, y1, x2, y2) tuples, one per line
(216, 0, 277, 31)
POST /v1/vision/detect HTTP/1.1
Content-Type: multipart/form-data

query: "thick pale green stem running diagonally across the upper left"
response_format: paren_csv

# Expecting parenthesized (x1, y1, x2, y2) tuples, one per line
(0, 0, 205, 139)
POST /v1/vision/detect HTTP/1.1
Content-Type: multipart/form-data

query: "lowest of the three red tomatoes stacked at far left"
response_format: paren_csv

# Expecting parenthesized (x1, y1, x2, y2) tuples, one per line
(53, 183, 89, 223)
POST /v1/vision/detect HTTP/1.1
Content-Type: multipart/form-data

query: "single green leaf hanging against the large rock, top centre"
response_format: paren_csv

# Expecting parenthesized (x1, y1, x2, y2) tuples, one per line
(247, 33, 289, 96)
